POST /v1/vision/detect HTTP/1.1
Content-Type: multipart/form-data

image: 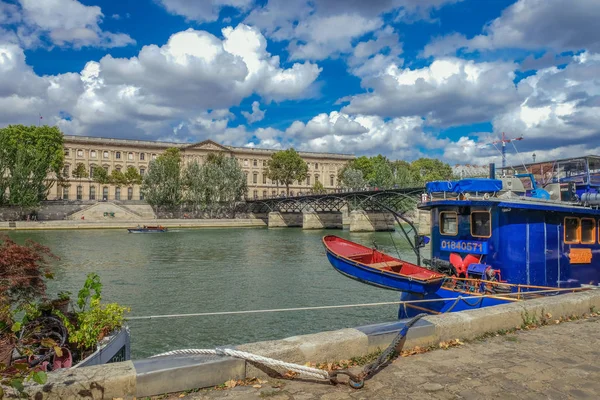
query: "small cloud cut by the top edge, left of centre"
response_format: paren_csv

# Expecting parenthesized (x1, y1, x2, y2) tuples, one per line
(158, 0, 254, 22)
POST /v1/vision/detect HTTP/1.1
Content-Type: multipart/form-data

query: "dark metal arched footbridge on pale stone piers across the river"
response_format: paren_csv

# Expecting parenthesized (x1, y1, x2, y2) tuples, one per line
(245, 187, 424, 232)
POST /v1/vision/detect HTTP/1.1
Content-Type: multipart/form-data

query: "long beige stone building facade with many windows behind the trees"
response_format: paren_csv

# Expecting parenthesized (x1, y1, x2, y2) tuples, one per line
(54, 135, 354, 200)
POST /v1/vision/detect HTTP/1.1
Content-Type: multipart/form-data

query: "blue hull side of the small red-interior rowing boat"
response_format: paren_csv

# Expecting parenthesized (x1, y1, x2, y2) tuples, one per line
(327, 250, 443, 294)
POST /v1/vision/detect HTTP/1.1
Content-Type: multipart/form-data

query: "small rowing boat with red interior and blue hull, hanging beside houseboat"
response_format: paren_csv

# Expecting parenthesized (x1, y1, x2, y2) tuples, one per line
(323, 235, 447, 294)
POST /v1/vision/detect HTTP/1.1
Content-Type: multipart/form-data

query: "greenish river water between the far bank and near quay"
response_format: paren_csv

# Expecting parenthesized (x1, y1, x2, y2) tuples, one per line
(10, 228, 422, 358)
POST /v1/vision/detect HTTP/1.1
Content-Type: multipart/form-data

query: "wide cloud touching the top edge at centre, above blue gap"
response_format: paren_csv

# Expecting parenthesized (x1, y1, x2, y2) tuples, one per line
(246, 0, 456, 60)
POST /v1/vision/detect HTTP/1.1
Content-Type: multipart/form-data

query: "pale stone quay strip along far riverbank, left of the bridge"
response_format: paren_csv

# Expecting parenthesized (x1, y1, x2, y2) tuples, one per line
(0, 218, 267, 230)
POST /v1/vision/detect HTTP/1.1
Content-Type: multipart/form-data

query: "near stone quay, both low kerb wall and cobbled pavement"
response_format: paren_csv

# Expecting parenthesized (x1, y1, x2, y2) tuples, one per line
(19, 290, 600, 400)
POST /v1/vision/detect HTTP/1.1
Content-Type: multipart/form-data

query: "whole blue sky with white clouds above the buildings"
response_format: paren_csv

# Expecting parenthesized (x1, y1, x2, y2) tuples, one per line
(0, 0, 600, 165)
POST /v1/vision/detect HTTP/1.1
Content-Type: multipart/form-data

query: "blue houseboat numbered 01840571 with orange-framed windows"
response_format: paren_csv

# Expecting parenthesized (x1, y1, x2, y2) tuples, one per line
(399, 156, 600, 317)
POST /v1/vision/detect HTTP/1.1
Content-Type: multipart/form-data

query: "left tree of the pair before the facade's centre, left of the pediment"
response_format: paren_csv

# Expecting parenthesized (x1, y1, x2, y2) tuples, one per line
(142, 148, 183, 208)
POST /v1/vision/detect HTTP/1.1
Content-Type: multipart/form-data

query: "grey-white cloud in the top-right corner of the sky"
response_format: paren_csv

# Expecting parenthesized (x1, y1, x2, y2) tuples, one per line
(423, 0, 600, 57)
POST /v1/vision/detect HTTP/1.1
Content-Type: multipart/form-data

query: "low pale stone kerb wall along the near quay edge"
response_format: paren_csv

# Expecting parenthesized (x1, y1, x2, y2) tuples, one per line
(27, 290, 600, 399)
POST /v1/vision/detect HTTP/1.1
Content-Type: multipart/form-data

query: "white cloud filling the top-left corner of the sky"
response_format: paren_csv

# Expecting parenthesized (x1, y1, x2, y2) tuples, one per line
(0, 0, 135, 48)
